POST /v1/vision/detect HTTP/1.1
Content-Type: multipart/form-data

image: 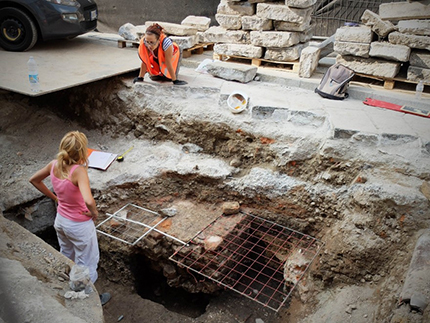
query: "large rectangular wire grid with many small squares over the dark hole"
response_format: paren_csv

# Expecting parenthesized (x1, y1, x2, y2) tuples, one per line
(169, 212, 324, 312)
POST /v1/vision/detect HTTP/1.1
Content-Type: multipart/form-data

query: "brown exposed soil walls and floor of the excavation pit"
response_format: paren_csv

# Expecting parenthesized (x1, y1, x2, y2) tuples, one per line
(0, 77, 429, 322)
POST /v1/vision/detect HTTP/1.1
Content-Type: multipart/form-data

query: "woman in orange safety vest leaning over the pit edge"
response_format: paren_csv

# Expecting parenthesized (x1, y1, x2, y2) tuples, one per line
(133, 24, 187, 85)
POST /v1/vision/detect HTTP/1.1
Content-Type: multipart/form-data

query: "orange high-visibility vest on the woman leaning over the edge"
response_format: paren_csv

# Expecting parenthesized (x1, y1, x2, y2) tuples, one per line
(138, 33, 180, 79)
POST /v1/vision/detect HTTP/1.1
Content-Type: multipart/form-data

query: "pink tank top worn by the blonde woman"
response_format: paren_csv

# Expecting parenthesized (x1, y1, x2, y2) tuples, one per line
(51, 161, 91, 222)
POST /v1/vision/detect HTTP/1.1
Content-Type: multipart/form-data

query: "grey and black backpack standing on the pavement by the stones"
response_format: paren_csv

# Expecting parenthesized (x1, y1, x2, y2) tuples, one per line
(315, 64, 355, 100)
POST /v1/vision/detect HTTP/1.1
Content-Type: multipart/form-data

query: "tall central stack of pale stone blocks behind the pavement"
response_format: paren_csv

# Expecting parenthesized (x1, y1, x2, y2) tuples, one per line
(207, 0, 316, 62)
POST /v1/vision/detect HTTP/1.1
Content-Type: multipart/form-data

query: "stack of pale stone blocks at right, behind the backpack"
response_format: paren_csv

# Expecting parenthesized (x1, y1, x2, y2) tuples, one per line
(334, 1, 430, 84)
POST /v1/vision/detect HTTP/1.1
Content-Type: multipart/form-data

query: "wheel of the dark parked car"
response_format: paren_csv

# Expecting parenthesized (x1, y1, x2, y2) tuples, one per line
(0, 7, 37, 52)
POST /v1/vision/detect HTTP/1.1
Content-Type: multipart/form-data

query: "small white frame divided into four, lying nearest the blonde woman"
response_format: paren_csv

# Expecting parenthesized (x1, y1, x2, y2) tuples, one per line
(96, 204, 166, 245)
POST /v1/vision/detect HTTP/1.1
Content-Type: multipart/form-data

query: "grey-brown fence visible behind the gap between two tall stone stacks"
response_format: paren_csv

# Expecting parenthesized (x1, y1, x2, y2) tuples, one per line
(312, 0, 404, 37)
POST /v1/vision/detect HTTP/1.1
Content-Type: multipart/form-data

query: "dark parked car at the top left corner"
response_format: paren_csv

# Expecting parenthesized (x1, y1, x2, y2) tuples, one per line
(0, 0, 98, 52)
